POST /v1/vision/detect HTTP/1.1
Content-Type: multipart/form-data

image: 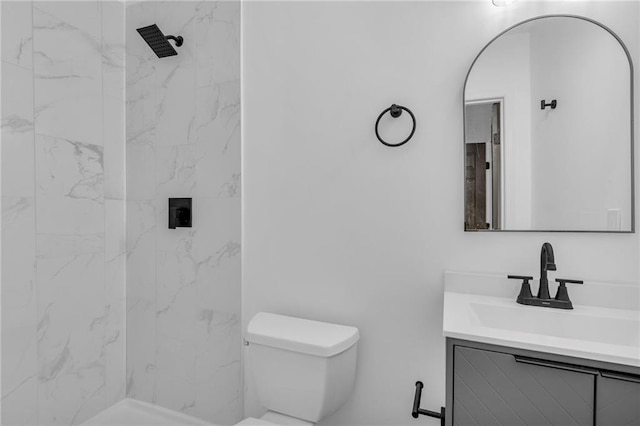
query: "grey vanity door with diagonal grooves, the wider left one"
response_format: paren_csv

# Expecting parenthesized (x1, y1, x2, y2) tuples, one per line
(453, 346, 606, 426)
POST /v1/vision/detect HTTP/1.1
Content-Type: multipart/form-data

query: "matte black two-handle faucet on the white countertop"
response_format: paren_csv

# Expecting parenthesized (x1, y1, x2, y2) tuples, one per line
(508, 243, 582, 309)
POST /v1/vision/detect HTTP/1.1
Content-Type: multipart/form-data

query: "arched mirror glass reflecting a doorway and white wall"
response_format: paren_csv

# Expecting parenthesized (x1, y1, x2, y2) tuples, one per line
(464, 16, 634, 232)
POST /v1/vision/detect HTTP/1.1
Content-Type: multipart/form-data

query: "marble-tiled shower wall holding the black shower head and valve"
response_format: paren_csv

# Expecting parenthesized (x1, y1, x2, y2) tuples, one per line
(126, 1, 242, 424)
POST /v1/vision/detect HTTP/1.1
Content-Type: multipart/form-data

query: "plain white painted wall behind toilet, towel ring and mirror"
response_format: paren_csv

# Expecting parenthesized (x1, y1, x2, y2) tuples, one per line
(243, 1, 640, 425)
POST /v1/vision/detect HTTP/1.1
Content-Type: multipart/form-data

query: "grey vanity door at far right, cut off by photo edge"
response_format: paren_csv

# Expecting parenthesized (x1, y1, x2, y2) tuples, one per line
(596, 372, 640, 426)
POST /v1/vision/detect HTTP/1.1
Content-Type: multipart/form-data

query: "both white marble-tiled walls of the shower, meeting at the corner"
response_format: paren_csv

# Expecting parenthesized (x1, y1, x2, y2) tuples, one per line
(1, 1, 242, 425)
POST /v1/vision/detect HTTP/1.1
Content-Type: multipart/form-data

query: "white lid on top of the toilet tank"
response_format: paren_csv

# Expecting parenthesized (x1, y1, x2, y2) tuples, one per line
(246, 312, 360, 357)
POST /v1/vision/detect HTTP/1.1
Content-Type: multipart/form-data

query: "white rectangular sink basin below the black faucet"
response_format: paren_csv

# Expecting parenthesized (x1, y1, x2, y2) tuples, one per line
(470, 302, 640, 347)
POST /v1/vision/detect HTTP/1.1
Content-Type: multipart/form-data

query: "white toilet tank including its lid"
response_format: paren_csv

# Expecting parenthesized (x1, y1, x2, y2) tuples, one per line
(246, 312, 359, 423)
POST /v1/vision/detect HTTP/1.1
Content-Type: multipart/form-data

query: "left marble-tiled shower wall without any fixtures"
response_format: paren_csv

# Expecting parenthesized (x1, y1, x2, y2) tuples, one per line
(0, 1, 126, 425)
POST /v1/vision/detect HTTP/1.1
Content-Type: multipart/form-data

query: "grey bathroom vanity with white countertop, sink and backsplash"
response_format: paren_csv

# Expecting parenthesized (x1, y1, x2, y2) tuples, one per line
(443, 272, 640, 426)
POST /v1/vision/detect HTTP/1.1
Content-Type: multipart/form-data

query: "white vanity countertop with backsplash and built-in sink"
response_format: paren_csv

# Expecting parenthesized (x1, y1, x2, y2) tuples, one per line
(443, 272, 640, 367)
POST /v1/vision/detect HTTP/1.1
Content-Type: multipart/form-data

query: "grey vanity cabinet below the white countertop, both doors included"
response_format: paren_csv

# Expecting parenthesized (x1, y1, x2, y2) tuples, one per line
(445, 338, 640, 426)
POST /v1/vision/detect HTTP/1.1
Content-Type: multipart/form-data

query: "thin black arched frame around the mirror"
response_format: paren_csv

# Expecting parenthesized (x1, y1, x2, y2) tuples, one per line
(462, 14, 636, 234)
